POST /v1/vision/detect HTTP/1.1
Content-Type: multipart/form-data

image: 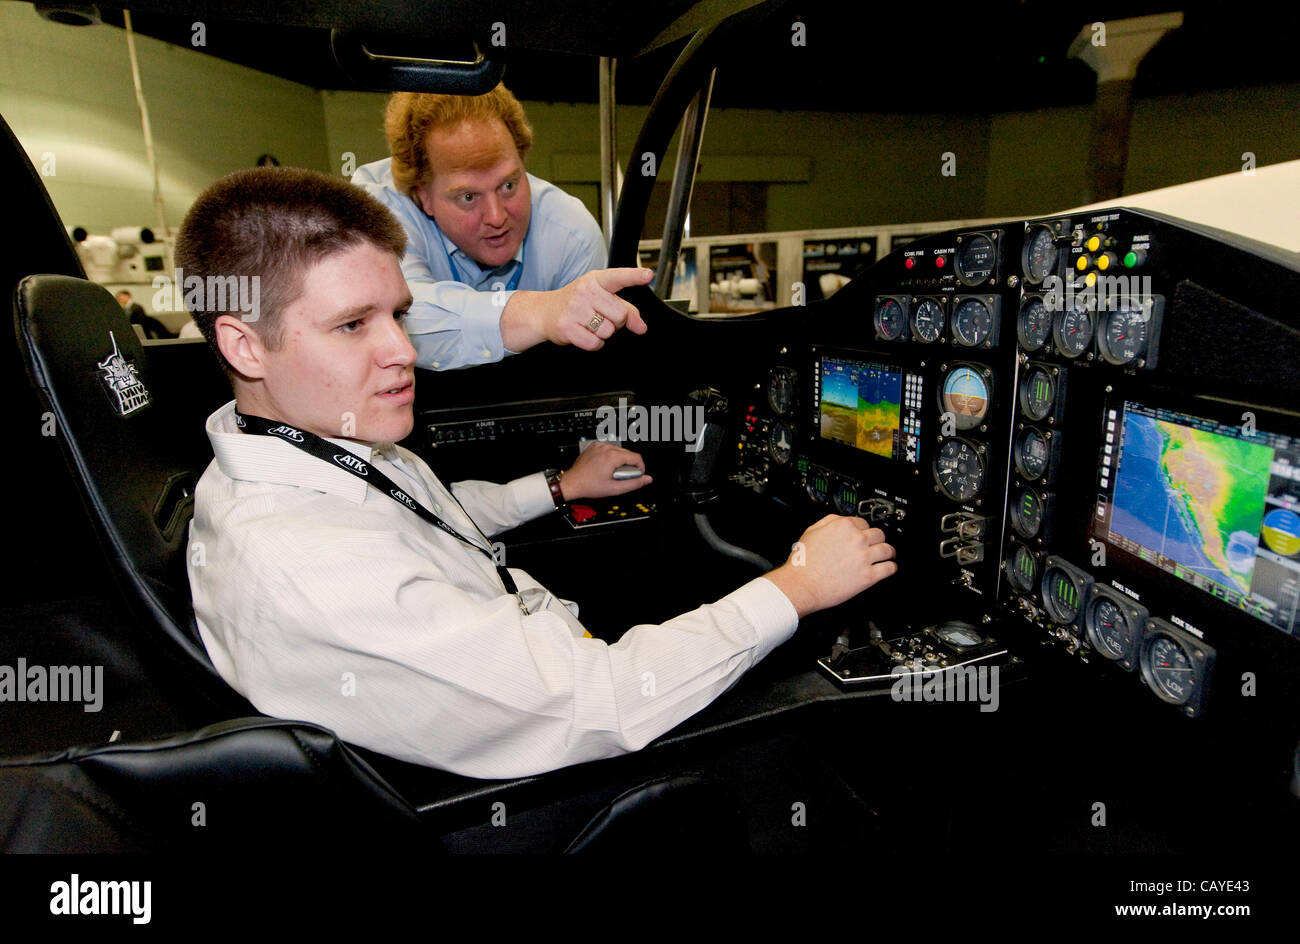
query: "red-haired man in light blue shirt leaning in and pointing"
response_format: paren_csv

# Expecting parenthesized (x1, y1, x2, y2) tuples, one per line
(352, 86, 653, 371)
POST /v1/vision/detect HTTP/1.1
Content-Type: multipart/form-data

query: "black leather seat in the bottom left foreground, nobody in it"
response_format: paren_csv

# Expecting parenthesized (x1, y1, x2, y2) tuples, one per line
(0, 718, 428, 853)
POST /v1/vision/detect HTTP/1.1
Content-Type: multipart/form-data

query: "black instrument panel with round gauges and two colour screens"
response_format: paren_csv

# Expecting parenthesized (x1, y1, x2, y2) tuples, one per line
(732, 209, 1300, 718)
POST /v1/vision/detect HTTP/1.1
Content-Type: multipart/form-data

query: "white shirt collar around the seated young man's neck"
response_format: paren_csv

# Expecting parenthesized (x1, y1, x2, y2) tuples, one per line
(207, 400, 397, 505)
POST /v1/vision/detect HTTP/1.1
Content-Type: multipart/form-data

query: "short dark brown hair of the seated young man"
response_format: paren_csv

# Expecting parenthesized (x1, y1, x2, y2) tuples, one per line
(176, 166, 406, 373)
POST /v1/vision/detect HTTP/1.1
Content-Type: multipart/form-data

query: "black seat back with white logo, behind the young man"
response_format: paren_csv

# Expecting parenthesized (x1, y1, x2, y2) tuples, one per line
(14, 276, 248, 723)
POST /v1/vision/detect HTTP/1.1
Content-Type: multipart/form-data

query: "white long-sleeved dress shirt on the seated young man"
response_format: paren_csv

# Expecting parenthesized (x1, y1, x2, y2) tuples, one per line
(189, 402, 798, 778)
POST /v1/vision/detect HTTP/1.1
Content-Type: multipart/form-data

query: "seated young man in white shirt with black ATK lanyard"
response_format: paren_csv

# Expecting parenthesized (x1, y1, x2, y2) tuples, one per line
(176, 168, 896, 778)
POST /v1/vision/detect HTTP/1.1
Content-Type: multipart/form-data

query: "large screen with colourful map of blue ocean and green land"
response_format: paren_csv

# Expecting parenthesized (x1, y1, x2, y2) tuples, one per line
(1095, 402, 1300, 635)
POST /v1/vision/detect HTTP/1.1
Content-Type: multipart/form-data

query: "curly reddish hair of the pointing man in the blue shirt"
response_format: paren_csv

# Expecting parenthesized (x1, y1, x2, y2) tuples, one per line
(384, 85, 533, 194)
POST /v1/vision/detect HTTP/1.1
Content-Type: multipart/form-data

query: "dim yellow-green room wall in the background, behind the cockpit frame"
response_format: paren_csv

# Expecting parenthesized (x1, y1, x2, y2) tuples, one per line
(0, 3, 1300, 241)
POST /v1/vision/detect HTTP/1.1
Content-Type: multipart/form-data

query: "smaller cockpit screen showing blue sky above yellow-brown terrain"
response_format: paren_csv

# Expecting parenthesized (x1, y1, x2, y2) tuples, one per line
(820, 358, 902, 459)
